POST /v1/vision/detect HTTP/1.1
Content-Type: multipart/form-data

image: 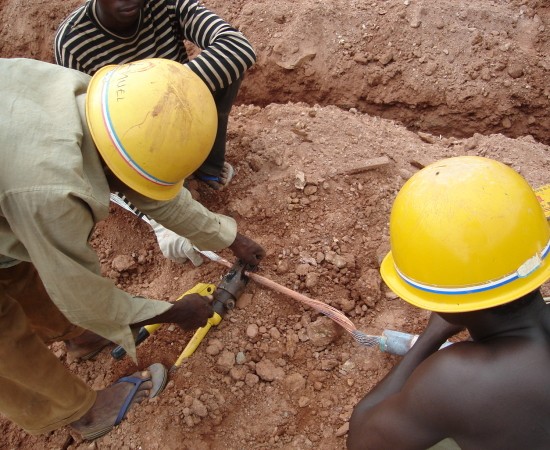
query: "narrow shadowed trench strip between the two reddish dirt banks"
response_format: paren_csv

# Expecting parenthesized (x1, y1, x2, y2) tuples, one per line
(238, 68, 550, 145)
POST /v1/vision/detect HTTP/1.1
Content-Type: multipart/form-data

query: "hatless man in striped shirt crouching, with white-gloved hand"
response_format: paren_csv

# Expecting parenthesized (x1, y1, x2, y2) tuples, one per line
(54, 0, 256, 265)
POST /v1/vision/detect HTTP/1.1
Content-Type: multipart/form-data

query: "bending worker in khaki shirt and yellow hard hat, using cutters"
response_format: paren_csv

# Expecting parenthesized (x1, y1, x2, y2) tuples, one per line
(0, 59, 264, 439)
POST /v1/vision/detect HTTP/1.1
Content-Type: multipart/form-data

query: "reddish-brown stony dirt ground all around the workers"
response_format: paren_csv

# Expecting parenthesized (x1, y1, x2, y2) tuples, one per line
(0, 0, 550, 450)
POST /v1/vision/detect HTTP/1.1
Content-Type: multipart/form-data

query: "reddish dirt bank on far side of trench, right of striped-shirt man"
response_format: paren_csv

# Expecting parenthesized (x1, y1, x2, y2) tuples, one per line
(227, 0, 550, 145)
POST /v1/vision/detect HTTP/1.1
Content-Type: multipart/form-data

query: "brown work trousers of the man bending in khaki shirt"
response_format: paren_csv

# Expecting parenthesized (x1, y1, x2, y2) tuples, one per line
(0, 262, 96, 434)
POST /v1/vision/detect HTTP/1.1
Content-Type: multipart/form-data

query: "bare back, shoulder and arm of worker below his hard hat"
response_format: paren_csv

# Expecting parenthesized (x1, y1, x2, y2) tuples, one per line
(348, 292, 550, 450)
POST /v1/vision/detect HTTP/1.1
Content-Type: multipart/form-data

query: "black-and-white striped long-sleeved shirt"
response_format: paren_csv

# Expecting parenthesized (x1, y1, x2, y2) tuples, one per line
(54, 0, 256, 91)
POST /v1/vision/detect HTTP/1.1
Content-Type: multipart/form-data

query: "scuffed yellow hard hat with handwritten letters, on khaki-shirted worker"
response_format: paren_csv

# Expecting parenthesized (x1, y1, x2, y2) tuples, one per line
(86, 58, 218, 200)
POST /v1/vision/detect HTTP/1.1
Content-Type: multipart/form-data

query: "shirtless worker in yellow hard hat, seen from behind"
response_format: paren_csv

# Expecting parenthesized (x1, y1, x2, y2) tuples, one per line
(347, 156, 550, 450)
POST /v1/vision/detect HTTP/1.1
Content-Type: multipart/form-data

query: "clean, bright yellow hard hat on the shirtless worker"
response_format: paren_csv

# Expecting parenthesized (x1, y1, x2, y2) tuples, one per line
(380, 156, 550, 312)
